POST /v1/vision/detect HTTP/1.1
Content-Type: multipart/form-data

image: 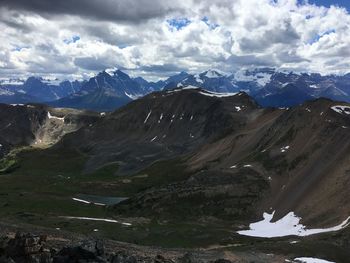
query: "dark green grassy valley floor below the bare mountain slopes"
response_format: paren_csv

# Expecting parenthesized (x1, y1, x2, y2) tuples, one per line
(0, 148, 350, 262)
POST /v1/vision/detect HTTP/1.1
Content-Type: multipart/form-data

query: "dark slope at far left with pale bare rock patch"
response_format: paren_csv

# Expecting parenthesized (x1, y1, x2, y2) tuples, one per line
(0, 104, 99, 157)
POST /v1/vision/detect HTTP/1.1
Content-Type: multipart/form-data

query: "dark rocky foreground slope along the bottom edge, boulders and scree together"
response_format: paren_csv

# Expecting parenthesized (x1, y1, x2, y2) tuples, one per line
(0, 232, 290, 263)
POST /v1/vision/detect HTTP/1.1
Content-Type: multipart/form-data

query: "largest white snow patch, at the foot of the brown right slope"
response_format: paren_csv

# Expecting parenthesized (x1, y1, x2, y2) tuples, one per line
(237, 212, 350, 238)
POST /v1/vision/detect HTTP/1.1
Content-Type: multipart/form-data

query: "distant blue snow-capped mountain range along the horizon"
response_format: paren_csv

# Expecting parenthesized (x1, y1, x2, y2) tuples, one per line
(0, 68, 350, 111)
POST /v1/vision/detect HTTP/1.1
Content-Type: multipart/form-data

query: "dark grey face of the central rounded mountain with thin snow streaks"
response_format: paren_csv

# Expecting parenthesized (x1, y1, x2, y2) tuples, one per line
(55, 89, 257, 174)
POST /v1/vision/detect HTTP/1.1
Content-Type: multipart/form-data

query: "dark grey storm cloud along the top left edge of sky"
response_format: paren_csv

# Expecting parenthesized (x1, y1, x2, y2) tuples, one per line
(0, 0, 177, 23)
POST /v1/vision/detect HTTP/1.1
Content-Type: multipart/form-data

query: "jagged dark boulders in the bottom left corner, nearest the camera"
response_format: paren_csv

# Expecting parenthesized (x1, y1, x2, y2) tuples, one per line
(0, 233, 231, 263)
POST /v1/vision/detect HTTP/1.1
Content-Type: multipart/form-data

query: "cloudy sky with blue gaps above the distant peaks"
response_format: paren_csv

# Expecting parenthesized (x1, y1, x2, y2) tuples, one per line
(0, 0, 350, 80)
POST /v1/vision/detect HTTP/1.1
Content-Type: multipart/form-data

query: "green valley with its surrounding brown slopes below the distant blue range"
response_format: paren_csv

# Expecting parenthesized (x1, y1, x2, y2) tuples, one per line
(0, 88, 350, 262)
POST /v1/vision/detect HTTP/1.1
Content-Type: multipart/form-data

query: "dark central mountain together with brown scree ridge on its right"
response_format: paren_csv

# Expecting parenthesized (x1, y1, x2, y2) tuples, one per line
(46, 89, 350, 230)
